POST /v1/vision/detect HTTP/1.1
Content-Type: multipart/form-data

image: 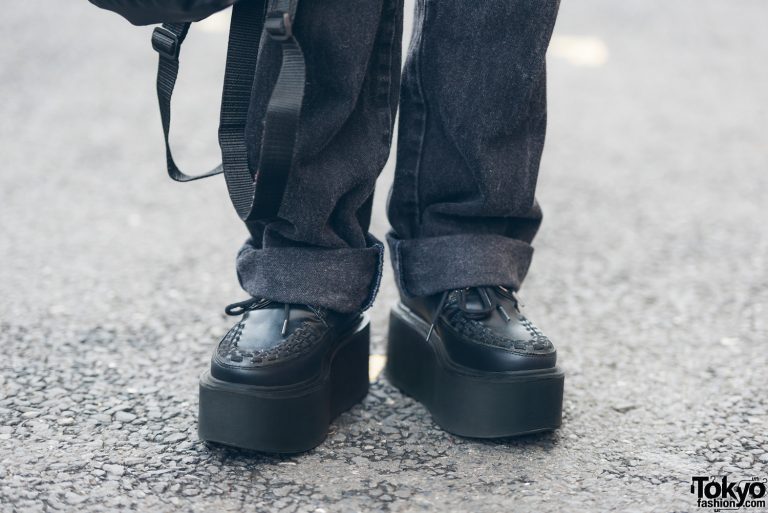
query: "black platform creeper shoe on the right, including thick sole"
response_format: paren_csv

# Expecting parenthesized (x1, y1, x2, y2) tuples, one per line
(387, 286, 564, 438)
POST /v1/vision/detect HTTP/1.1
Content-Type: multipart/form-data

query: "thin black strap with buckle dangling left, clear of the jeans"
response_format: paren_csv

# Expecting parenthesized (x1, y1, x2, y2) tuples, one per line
(152, 23, 223, 182)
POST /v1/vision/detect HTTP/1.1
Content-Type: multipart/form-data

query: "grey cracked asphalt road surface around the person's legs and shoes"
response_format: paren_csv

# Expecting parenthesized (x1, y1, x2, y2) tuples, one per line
(0, 0, 768, 513)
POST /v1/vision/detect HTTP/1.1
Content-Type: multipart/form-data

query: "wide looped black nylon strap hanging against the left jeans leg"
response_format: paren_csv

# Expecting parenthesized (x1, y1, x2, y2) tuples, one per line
(219, 0, 306, 222)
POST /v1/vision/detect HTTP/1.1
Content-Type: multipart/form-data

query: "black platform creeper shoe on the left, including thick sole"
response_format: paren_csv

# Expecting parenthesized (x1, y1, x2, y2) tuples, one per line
(198, 298, 369, 453)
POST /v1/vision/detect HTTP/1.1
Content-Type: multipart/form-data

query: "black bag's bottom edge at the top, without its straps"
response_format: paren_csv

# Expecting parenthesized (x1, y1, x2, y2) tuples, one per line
(89, 0, 236, 25)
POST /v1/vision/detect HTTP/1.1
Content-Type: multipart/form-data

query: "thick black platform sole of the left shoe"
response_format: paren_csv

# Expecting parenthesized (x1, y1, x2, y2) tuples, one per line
(198, 318, 370, 453)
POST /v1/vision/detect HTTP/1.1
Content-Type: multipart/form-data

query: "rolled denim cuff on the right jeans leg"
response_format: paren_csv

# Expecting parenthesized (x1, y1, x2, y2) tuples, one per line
(387, 232, 533, 296)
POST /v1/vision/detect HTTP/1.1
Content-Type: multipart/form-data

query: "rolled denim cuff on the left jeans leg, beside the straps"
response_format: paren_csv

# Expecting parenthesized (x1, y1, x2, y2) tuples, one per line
(237, 235, 384, 313)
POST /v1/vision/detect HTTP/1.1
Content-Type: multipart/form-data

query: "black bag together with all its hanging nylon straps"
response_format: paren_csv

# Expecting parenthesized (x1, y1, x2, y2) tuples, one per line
(97, 0, 306, 233)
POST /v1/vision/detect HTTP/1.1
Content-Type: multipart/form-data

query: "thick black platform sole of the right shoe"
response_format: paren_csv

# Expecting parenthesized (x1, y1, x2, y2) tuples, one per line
(386, 305, 564, 438)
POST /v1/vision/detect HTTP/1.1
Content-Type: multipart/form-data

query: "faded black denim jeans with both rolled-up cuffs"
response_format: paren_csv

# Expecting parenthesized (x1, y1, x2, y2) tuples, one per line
(237, 0, 559, 312)
